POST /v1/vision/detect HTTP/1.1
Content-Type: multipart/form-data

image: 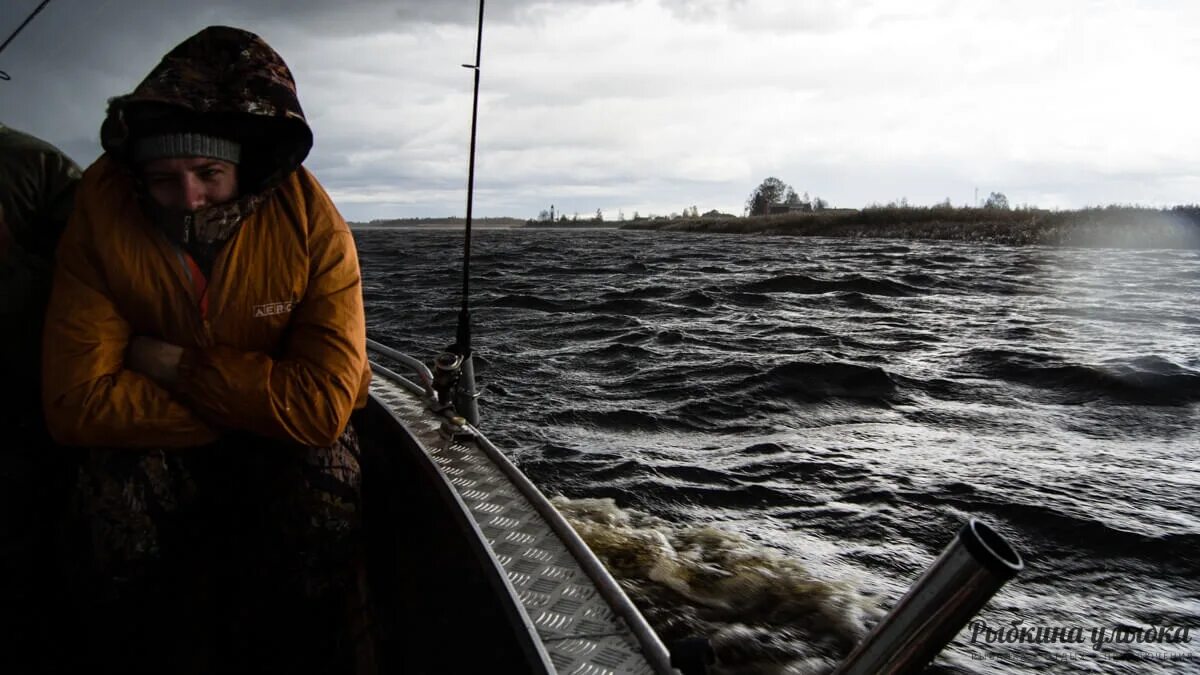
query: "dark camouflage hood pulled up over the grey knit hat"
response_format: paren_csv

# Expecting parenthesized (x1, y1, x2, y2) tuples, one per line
(100, 26, 312, 195)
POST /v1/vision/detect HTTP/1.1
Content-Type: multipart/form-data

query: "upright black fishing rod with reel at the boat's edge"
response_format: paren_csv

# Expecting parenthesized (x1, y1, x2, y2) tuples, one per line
(433, 0, 484, 425)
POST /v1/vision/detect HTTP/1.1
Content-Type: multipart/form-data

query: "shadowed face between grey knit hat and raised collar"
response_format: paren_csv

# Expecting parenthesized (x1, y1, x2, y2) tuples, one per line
(143, 157, 238, 211)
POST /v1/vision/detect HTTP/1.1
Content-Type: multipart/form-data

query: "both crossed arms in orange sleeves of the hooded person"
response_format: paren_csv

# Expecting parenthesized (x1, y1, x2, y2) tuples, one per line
(43, 177, 367, 447)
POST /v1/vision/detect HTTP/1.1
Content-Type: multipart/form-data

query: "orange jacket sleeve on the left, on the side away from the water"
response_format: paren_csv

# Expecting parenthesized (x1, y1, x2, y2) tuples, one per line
(42, 192, 217, 448)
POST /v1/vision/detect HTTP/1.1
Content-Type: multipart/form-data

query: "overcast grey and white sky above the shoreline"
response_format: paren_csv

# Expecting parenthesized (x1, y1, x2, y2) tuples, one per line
(0, 0, 1200, 220)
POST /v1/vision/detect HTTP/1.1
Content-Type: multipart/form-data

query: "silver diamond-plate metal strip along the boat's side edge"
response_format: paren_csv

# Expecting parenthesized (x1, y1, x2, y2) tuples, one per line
(371, 367, 655, 675)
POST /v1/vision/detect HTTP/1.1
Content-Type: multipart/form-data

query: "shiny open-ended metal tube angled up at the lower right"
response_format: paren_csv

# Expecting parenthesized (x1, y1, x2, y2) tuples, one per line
(834, 519, 1025, 675)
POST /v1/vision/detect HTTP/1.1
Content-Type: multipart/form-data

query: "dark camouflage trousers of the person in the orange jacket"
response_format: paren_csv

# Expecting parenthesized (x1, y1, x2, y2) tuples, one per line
(77, 426, 368, 673)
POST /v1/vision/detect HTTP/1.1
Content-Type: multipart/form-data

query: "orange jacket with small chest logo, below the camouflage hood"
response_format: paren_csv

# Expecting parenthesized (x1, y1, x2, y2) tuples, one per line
(43, 155, 370, 448)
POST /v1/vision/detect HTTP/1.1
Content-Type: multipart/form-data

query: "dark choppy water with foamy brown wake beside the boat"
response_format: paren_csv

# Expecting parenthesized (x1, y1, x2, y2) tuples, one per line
(356, 231, 1200, 673)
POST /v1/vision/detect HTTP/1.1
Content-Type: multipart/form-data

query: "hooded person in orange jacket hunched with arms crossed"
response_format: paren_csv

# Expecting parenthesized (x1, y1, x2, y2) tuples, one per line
(42, 26, 370, 673)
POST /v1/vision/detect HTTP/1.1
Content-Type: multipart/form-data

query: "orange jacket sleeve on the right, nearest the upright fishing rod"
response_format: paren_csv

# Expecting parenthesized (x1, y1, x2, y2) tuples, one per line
(171, 187, 368, 447)
